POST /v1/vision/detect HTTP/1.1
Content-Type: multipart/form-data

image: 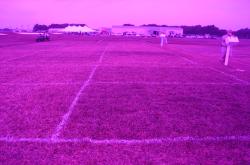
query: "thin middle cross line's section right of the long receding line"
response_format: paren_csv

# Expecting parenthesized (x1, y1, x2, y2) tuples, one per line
(92, 81, 250, 86)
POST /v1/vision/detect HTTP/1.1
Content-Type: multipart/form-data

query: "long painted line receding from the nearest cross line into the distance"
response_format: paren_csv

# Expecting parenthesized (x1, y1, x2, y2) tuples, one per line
(52, 46, 107, 139)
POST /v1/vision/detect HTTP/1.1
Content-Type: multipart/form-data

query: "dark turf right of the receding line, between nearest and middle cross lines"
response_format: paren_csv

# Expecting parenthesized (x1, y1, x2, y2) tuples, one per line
(63, 84, 250, 139)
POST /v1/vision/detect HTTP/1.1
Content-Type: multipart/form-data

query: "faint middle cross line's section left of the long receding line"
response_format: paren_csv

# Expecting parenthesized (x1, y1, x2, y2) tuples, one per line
(0, 82, 82, 86)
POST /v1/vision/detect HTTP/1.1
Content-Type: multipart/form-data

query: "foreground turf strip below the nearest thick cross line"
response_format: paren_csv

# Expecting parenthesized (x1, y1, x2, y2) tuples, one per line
(0, 142, 250, 165)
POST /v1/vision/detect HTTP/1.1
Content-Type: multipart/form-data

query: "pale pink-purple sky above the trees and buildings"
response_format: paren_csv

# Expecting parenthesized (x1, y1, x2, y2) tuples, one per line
(0, 0, 250, 30)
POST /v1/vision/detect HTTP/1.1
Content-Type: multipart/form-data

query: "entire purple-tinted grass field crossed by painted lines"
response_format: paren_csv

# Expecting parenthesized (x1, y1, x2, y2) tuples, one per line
(0, 34, 250, 165)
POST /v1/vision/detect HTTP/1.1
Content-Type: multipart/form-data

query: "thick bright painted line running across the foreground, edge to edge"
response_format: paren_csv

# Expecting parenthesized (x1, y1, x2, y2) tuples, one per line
(0, 135, 250, 145)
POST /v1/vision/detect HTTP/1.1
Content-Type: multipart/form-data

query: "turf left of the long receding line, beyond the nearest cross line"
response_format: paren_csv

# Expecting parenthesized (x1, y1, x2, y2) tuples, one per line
(0, 36, 105, 138)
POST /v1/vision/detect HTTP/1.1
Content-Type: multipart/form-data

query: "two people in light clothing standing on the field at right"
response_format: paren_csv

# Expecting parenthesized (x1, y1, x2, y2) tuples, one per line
(160, 30, 239, 65)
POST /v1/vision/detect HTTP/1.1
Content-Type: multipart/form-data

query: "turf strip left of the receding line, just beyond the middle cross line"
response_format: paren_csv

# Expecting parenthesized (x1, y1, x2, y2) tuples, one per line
(0, 64, 91, 84)
